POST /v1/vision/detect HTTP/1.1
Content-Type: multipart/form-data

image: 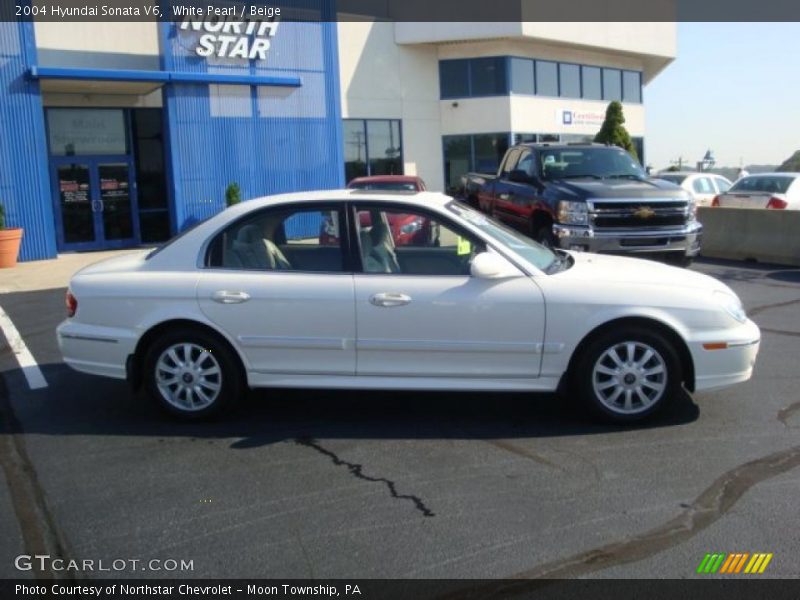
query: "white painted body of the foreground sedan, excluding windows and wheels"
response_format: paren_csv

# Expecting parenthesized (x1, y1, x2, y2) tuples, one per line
(58, 190, 760, 420)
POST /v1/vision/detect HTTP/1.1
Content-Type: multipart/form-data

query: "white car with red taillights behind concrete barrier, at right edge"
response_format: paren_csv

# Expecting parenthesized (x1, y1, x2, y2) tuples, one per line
(712, 173, 800, 210)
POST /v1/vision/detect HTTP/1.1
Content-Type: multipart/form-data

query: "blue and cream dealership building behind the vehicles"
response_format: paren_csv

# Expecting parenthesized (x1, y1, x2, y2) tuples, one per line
(0, 11, 676, 260)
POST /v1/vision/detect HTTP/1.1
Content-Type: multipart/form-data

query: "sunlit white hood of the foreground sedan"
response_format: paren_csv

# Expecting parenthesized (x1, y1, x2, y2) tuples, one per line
(554, 252, 733, 294)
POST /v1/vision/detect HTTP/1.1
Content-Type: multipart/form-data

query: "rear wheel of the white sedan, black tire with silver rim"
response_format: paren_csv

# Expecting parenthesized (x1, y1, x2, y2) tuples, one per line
(142, 327, 244, 421)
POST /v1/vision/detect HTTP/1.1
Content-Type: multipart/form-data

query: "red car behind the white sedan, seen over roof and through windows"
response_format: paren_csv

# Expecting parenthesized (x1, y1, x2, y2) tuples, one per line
(320, 175, 431, 246)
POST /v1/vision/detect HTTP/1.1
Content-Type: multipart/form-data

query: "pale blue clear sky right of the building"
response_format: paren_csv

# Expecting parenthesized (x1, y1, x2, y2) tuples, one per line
(644, 23, 800, 169)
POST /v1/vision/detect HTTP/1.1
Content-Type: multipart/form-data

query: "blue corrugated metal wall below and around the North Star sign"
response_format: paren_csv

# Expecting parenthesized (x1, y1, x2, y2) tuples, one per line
(161, 0, 344, 230)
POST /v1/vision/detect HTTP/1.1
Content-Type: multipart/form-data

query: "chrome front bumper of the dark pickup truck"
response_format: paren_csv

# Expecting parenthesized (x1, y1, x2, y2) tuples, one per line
(553, 221, 703, 257)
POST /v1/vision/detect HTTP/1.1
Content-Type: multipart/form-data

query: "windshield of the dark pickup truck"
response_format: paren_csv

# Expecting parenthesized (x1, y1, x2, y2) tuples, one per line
(539, 146, 647, 180)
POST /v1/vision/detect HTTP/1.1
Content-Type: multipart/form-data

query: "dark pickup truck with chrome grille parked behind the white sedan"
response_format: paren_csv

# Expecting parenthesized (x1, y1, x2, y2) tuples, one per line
(456, 143, 703, 264)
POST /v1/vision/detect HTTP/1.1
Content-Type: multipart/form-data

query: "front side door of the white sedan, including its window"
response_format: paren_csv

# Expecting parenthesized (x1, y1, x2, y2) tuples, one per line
(353, 206, 545, 379)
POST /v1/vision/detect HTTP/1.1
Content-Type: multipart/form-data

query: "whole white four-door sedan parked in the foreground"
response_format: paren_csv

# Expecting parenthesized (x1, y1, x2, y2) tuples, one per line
(58, 190, 760, 421)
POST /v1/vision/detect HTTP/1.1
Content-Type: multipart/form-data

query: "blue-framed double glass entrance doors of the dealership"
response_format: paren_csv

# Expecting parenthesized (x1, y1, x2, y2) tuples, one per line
(51, 156, 140, 250)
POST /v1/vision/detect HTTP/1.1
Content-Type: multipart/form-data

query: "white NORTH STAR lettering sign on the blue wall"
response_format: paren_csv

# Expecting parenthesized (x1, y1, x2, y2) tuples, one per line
(180, 18, 279, 60)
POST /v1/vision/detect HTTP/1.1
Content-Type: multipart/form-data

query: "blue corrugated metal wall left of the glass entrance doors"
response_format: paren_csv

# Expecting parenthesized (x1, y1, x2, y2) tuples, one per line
(0, 20, 56, 260)
